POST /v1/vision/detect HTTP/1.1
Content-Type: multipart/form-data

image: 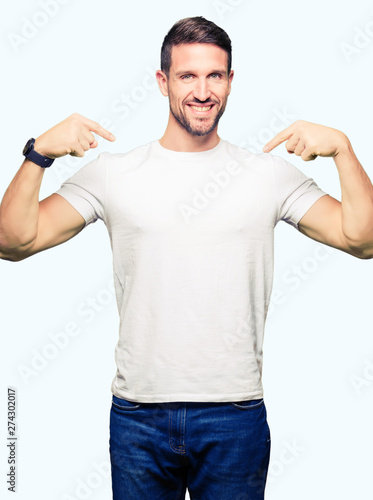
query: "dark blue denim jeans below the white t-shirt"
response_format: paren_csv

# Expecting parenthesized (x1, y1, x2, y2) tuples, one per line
(109, 395, 271, 500)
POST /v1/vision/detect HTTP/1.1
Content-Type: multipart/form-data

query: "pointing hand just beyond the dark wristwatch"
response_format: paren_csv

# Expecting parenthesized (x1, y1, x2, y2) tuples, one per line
(34, 113, 115, 158)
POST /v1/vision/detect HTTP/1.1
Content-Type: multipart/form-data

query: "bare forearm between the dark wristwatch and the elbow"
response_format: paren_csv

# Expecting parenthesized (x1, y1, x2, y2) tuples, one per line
(0, 159, 44, 256)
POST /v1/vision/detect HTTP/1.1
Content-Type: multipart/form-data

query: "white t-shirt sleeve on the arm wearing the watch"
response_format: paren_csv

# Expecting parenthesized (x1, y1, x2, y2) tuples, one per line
(56, 153, 106, 226)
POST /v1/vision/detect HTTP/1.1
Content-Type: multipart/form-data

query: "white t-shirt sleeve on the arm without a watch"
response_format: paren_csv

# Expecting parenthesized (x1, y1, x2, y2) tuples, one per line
(273, 156, 327, 230)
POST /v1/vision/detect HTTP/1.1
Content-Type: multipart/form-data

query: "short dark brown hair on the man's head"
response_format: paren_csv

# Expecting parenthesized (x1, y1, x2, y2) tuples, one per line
(161, 16, 232, 78)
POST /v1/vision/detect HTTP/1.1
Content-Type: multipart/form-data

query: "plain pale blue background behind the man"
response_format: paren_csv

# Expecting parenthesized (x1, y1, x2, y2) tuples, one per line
(0, 0, 373, 500)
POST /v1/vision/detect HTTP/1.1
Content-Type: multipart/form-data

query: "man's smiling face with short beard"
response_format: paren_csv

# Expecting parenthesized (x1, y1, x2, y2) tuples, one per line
(163, 43, 233, 136)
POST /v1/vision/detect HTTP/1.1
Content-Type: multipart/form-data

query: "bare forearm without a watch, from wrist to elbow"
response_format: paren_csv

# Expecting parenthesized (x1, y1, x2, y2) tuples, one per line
(334, 138, 373, 252)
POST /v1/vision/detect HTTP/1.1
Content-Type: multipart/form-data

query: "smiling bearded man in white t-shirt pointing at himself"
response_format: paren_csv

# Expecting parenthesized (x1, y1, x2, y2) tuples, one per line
(0, 17, 373, 500)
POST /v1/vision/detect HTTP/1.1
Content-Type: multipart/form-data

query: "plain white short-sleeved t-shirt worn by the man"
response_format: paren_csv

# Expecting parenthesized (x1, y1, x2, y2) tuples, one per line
(57, 139, 326, 403)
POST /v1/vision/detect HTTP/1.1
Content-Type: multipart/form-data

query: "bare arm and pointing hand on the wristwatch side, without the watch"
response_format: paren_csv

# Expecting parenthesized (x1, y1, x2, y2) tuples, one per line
(0, 113, 115, 261)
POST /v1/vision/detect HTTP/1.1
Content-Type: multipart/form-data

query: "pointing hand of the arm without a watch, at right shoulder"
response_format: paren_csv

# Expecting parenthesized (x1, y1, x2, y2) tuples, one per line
(263, 120, 348, 161)
